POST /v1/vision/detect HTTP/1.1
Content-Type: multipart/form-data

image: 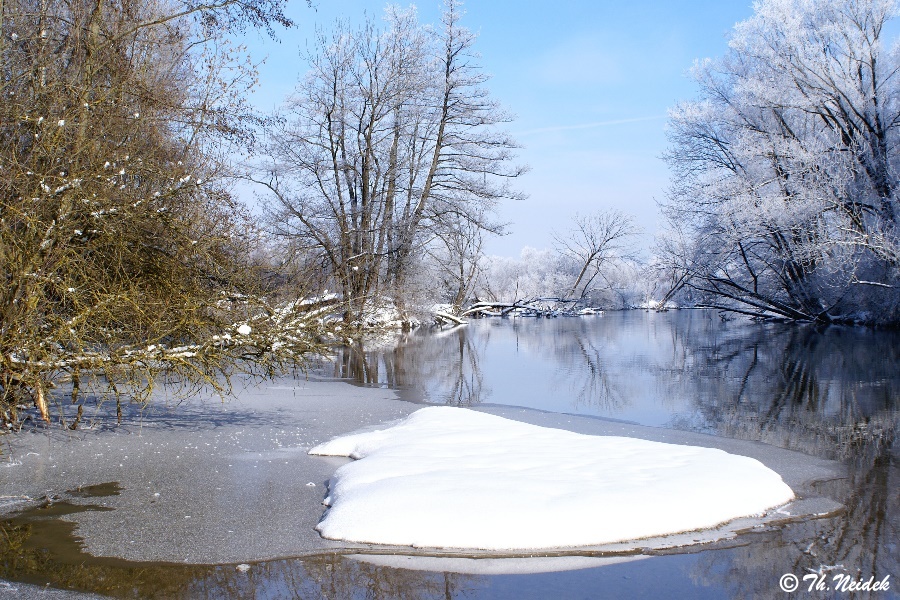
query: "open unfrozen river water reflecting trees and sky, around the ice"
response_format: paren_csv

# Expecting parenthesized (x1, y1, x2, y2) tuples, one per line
(0, 311, 900, 599)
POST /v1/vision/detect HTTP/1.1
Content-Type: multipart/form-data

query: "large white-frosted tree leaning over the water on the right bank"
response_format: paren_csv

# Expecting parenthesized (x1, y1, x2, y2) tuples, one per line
(666, 0, 900, 322)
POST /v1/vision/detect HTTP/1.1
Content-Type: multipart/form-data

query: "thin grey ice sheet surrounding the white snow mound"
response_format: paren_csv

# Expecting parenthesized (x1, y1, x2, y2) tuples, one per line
(0, 378, 841, 597)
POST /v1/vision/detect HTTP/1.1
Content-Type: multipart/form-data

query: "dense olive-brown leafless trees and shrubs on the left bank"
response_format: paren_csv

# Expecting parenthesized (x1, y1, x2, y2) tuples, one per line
(0, 0, 328, 425)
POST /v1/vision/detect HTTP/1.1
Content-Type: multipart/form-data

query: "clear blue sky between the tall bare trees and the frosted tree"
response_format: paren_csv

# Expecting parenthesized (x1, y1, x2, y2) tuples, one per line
(237, 0, 753, 256)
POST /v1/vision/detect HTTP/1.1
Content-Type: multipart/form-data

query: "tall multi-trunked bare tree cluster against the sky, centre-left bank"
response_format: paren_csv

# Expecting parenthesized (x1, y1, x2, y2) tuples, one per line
(258, 0, 522, 321)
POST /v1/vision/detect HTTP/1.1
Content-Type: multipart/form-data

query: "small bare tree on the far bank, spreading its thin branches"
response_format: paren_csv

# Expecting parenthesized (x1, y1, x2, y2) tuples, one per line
(553, 210, 638, 299)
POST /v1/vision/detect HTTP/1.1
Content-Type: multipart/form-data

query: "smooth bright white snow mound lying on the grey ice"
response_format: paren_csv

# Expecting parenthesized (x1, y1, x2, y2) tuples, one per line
(310, 407, 794, 550)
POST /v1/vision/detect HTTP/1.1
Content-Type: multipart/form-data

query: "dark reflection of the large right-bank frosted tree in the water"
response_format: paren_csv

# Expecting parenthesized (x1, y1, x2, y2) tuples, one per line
(672, 325, 900, 598)
